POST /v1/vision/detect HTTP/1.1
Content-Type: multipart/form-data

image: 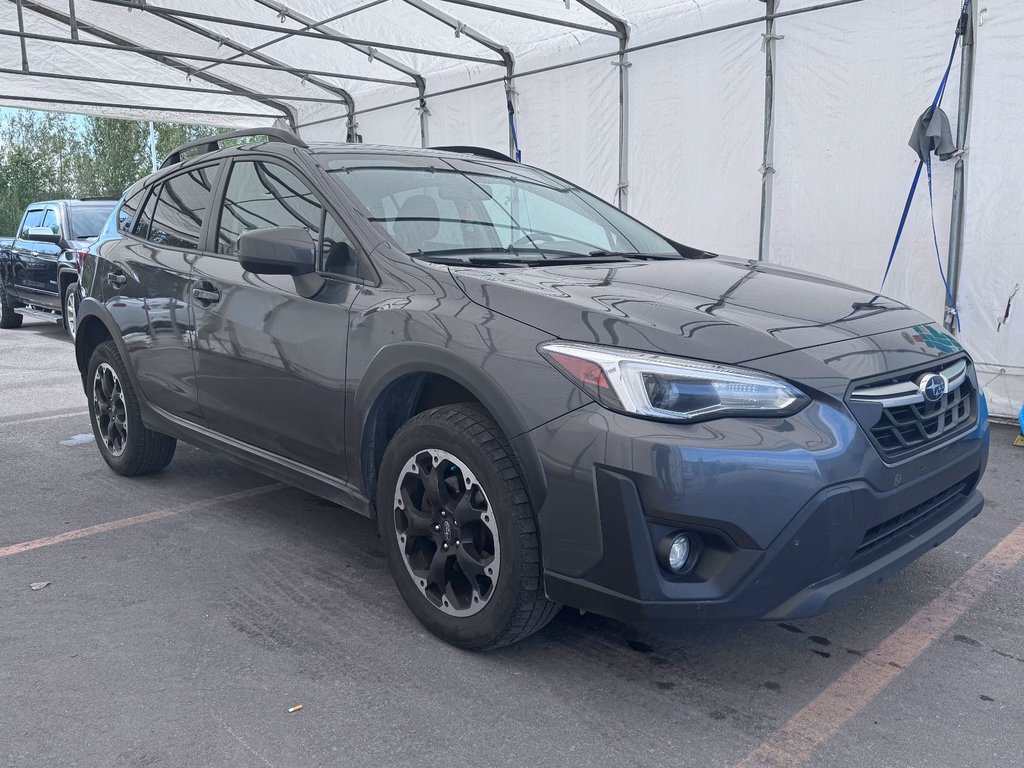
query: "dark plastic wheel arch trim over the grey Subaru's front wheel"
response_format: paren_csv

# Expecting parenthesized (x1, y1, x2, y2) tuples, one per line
(348, 342, 548, 509)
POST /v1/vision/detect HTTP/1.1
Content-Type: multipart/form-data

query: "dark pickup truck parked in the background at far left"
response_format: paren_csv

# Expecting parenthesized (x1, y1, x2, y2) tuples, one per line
(0, 199, 118, 338)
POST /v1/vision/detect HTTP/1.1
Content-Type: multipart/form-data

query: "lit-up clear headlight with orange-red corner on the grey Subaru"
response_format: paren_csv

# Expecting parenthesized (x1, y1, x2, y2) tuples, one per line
(538, 342, 810, 422)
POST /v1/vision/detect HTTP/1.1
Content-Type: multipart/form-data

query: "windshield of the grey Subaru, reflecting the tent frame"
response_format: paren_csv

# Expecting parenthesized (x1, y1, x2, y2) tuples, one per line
(325, 155, 679, 261)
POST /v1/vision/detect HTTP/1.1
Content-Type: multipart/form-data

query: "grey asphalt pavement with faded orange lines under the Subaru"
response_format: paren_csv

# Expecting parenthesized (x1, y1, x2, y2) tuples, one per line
(0, 322, 1024, 768)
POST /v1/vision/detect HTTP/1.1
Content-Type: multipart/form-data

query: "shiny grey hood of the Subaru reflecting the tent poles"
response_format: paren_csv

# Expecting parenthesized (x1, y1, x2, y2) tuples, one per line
(452, 257, 931, 362)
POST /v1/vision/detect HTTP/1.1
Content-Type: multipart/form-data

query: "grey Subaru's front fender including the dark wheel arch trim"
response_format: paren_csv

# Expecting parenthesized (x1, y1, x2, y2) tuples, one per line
(346, 252, 590, 502)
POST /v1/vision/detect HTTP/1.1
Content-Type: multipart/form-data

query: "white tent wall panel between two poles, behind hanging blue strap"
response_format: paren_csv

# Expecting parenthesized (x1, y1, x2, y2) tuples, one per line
(770, 0, 959, 321)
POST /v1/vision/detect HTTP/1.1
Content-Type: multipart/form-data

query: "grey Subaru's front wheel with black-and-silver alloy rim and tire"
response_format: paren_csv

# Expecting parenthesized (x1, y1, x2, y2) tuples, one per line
(377, 403, 560, 650)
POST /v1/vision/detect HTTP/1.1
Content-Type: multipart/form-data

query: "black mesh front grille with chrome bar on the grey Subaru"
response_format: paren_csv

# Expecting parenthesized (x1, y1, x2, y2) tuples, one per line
(850, 360, 978, 460)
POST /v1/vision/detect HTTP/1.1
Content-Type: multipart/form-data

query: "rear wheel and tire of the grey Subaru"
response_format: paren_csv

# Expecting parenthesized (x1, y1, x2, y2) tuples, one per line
(85, 341, 177, 477)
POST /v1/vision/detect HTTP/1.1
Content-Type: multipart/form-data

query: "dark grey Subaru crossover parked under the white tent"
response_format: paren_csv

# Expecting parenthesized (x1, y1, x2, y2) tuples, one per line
(76, 131, 989, 648)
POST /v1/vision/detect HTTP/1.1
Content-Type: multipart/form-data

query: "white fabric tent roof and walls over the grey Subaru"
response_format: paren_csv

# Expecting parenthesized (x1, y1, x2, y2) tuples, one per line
(0, 0, 1024, 416)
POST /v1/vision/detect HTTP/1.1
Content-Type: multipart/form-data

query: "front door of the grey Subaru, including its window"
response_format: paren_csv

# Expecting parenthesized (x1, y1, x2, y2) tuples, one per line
(193, 160, 357, 477)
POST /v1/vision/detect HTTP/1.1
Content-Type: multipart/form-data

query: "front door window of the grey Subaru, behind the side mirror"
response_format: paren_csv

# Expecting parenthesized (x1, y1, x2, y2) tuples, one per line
(217, 162, 323, 256)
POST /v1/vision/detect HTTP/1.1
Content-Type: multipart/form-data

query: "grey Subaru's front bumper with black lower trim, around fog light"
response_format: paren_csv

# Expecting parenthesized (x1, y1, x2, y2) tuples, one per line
(518, 401, 988, 620)
